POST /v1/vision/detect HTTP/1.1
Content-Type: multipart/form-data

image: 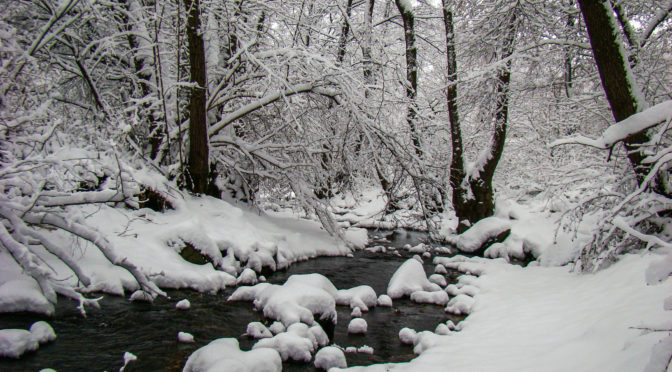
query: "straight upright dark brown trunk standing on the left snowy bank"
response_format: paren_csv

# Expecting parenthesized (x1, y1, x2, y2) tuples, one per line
(184, 0, 209, 194)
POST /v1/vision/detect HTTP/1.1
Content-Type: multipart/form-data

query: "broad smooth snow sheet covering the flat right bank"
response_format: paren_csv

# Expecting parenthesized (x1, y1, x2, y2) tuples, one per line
(342, 253, 672, 372)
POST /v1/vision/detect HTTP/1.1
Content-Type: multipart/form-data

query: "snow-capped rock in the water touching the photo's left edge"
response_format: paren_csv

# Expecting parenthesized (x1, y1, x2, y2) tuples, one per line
(0, 321, 56, 359)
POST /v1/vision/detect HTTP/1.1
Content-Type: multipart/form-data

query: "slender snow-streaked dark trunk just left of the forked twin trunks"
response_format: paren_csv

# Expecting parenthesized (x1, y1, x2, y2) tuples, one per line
(395, 0, 423, 158)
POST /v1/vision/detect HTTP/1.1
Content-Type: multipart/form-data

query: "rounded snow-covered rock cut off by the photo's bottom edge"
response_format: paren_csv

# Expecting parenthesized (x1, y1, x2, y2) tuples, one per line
(182, 338, 282, 372)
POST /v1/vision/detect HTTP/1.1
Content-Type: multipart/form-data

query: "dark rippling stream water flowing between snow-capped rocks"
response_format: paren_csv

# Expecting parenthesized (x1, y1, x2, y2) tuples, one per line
(0, 231, 462, 372)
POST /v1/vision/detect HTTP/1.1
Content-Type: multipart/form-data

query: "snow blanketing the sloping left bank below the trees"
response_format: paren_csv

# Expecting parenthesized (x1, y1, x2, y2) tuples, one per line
(0, 193, 350, 315)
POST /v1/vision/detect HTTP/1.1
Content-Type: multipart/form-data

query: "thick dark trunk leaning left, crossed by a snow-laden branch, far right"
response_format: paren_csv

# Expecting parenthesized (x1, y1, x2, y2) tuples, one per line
(579, 0, 651, 183)
